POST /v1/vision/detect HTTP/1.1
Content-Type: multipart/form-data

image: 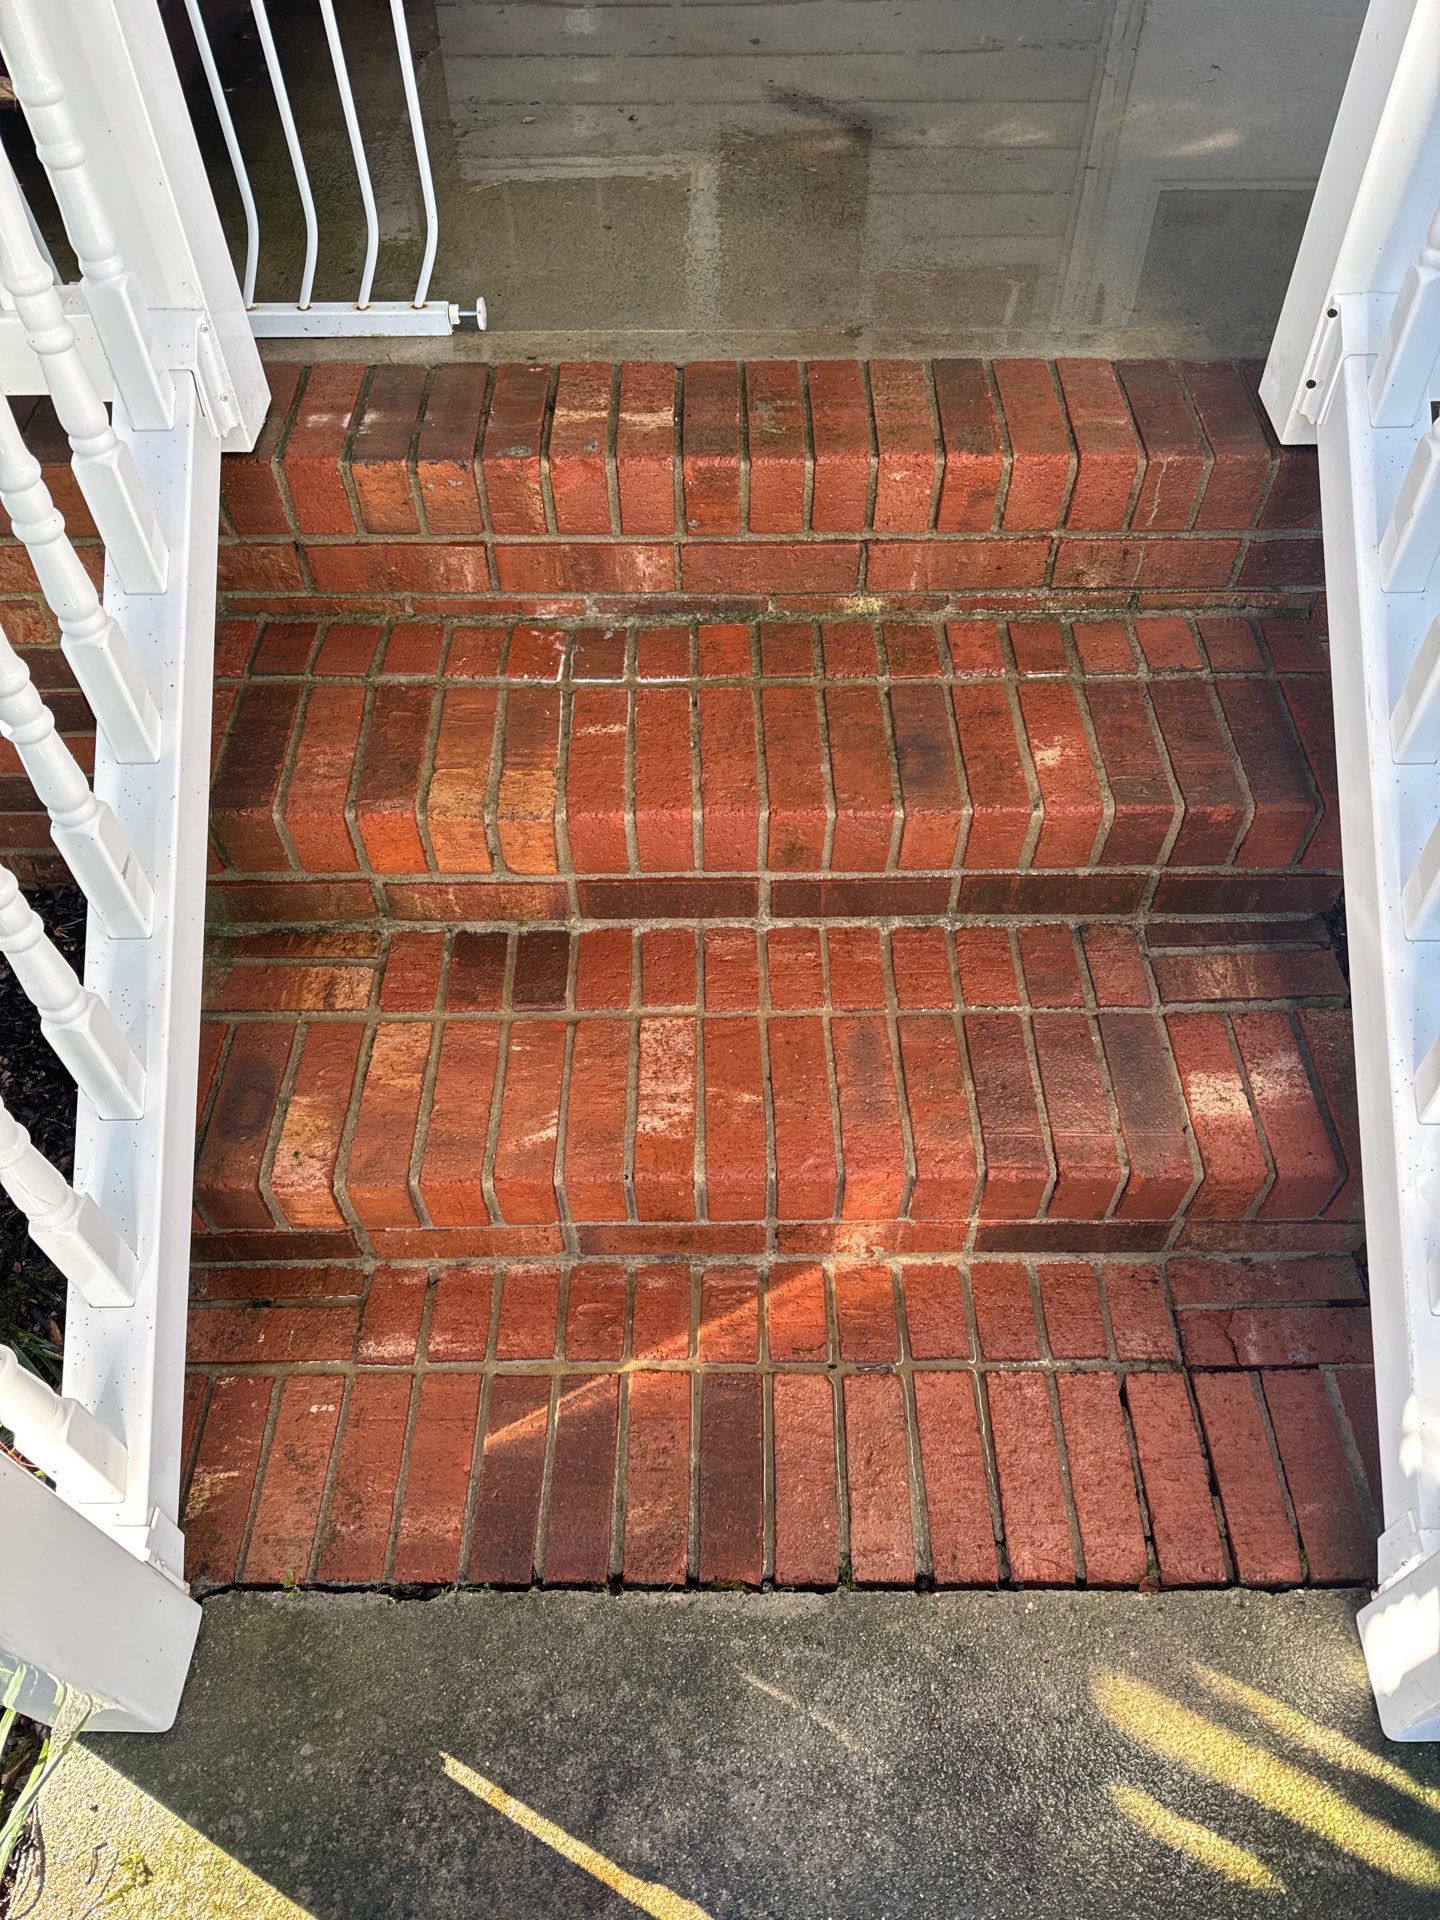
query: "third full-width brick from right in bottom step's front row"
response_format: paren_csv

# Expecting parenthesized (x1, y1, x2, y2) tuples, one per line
(1125, 1373, 1229, 1586)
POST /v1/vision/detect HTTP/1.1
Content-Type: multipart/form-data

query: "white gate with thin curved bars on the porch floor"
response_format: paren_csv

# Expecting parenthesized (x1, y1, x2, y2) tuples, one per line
(184, 0, 474, 336)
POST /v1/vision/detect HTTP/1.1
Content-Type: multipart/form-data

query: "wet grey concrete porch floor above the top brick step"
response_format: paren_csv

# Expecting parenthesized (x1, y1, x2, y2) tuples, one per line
(163, 0, 1365, 359)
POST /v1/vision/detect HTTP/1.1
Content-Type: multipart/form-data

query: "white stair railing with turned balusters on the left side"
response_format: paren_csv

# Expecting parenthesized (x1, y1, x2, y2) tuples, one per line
(0, 0, 267, 1728)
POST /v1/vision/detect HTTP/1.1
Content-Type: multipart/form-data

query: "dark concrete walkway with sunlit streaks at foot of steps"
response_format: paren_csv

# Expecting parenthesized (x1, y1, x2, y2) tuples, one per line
(19, 1592, 1440, 1920)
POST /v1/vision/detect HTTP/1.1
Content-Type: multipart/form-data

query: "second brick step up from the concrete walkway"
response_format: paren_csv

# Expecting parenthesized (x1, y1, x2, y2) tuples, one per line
(196, 922, 1361, 1258)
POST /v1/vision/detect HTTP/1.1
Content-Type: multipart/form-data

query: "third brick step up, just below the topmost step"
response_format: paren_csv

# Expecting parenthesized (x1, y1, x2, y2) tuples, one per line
(183, 614, 1340, 924)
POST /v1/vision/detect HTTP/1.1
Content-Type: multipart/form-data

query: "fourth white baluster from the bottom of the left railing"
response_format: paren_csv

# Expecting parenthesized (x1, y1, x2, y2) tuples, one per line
(0, 628, 156, 939)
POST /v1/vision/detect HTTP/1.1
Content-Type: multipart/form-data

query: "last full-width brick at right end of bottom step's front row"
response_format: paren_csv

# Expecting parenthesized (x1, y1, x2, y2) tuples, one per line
(1261, 1373, 1375, 1586)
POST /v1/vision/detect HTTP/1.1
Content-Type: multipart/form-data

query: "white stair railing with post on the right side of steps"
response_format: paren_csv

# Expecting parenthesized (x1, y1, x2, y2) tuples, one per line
(1261, 0, 1440, 1740)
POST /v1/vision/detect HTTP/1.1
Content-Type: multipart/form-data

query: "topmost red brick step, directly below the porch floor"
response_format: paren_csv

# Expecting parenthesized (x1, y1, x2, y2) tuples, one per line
(211, 359, 1321, 612)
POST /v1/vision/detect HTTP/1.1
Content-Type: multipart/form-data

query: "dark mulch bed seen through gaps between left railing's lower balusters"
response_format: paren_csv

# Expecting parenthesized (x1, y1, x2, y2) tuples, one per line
(0, 887, 84, 1914)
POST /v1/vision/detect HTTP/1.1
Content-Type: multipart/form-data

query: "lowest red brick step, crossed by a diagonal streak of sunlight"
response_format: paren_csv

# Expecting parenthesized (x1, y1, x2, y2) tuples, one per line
(184, 1256, 1380, 1588)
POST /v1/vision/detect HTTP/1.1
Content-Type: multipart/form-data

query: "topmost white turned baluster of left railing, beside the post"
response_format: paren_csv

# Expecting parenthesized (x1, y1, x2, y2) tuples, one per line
(0, 0, 175, 428)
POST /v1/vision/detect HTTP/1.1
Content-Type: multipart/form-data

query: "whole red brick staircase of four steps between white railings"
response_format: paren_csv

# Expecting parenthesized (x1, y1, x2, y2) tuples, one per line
(0, 361, 1377, 1586)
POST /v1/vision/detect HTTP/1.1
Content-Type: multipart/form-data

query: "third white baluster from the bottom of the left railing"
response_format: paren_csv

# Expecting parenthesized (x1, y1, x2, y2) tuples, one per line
(0, 866, 146, 1119)
